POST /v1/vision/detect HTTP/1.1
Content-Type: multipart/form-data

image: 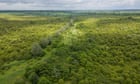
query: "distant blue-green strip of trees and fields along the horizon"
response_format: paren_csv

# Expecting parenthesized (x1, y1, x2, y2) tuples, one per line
(0, 10, 140, 16)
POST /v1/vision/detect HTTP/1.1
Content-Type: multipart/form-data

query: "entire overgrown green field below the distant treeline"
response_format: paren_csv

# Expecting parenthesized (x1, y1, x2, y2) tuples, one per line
(0, 14, 140, 84)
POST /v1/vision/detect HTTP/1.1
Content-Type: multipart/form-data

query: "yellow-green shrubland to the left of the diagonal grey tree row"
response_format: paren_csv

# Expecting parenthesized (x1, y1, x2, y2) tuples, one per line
(0, 14, 68, 64)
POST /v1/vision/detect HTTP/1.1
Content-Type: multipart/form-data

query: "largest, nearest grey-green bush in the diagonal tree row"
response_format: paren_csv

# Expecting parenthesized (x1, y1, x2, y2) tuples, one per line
(31, 44, 45, 57)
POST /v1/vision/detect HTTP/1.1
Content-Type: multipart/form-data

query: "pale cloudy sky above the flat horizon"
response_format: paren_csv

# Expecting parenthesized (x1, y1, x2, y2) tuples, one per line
(0, 0, 140, 10)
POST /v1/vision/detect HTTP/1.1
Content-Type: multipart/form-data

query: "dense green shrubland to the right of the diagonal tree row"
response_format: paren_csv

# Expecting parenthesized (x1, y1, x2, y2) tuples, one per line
(24, 14, 140, 84)
